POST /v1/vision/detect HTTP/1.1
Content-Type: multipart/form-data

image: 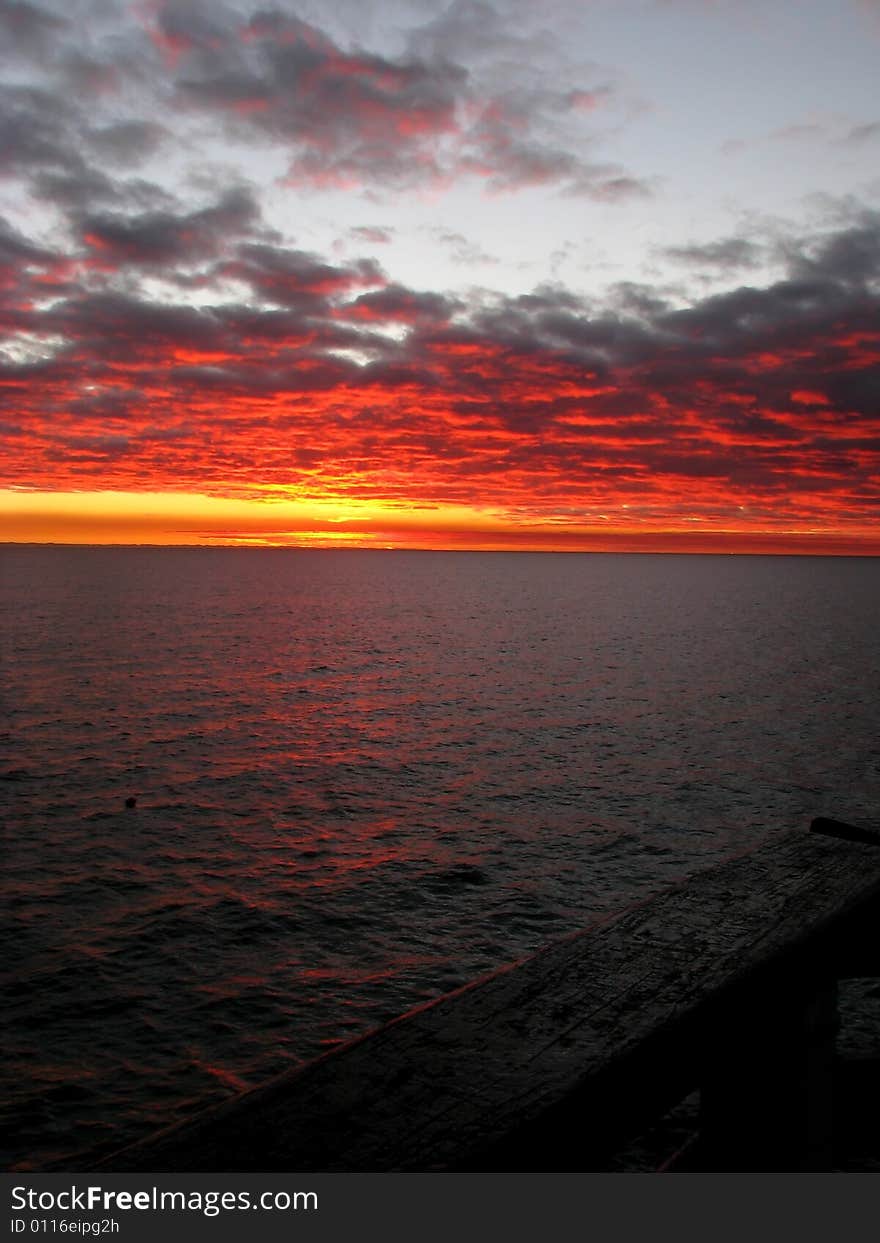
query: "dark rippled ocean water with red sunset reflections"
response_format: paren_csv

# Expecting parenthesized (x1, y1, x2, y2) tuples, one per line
(0, 546, 880, 1167)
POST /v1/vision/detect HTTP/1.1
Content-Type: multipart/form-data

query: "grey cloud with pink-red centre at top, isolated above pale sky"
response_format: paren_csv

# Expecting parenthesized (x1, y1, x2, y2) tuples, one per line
(128, 2, 648, 201)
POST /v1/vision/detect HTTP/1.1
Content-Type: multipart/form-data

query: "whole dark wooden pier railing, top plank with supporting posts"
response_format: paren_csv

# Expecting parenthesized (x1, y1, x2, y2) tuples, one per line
(92, 820, 880, 1172)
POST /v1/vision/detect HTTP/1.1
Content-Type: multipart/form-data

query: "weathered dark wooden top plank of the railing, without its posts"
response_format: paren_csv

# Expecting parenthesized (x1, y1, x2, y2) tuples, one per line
(87, 833, 880, 1172)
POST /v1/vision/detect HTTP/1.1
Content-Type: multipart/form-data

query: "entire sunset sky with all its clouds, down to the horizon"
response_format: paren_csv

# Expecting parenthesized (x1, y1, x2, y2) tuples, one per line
(0, 0, 880, 554)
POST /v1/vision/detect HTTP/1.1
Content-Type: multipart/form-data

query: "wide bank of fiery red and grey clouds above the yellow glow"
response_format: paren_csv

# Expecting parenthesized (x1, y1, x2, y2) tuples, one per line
(0, 213, 880, 546)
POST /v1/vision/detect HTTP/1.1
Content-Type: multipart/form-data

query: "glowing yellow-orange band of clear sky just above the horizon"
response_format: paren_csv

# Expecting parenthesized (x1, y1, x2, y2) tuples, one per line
(0, 490, 880, 556)
